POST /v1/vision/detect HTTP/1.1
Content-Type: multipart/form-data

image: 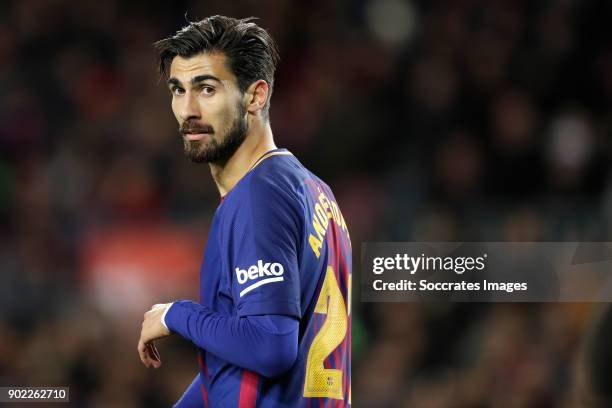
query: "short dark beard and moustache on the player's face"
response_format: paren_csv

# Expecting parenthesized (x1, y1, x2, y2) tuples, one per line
(179, 104, 248, 164)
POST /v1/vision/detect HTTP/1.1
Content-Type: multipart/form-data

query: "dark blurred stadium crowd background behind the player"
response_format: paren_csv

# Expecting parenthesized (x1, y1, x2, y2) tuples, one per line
(0, 0, 612, 408)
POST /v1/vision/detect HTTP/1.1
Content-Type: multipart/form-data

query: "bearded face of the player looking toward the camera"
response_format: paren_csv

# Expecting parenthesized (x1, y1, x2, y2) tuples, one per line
(168, 53, 248, 163)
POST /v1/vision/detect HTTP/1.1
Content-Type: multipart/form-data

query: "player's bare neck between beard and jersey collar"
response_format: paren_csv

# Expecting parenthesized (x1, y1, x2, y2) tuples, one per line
(210, 121, 276, 197)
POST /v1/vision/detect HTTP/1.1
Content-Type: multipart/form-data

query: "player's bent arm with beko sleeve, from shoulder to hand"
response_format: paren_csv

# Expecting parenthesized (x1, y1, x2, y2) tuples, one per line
(138, 177, 304, 377)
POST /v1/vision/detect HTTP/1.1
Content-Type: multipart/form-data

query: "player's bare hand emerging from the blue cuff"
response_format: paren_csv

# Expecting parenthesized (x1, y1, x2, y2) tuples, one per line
(138, 303, 172, 368)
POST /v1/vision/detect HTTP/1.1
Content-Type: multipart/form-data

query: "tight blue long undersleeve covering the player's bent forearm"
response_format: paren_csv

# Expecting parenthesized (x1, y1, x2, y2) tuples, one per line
(164, 300, 299, 377)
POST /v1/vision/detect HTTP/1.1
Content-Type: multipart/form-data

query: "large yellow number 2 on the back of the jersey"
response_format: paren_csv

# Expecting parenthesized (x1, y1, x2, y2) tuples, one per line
(304, 266, 350, 399)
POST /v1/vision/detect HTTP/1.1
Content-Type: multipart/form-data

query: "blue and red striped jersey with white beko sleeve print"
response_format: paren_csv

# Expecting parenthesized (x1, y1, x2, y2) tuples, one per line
(198, 149, 352, 408)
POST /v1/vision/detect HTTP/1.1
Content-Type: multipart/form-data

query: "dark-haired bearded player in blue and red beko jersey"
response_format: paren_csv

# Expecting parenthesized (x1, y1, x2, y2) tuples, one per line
(138, 16, 351, 408)
